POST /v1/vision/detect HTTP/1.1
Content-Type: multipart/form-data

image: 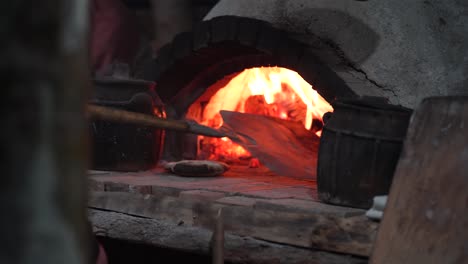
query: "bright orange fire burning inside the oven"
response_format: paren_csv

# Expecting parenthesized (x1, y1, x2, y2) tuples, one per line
(187, 67, 333, 163)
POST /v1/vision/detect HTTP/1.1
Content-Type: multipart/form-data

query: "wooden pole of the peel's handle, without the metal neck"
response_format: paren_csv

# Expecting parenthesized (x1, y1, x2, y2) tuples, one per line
(88, 105, 191, 132)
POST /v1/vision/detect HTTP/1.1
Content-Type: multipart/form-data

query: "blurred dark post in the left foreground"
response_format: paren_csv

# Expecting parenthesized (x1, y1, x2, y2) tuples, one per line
(0, 0, 89, 264)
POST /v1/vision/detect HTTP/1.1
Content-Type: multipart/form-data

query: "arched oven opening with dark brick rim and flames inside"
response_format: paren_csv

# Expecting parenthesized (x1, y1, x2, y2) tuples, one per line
(140, 16, 356, 177)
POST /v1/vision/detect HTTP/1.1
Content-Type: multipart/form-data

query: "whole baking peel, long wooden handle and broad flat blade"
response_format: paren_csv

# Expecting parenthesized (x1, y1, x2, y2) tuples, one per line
(88, 105, 317, 178)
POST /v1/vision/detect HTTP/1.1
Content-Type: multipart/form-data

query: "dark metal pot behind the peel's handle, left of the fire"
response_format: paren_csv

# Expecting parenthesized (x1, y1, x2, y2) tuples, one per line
(90, 77, 164, 171)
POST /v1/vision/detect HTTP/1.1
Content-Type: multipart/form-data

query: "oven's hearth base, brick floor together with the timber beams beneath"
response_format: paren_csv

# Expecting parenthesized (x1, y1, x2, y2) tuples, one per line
(88, 166, 378, 263)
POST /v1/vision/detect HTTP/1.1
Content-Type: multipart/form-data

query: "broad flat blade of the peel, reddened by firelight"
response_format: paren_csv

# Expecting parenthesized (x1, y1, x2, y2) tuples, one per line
(220, 110, 318, 179)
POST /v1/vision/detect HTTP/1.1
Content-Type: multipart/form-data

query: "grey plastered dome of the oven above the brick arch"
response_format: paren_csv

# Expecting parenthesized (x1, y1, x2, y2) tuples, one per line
(205, 0, 468, 108)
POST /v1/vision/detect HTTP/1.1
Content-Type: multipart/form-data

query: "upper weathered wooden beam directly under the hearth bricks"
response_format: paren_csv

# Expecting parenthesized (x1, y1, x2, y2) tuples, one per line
(89, 192, 377, 256)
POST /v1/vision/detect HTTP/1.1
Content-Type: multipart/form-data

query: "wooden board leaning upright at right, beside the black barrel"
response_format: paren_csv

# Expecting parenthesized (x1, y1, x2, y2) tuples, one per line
(371, 97, 468, 264)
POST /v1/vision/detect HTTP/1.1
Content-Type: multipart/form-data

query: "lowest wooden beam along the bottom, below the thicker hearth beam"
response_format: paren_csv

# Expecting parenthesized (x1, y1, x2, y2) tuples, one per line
(89, 209, 367, 264)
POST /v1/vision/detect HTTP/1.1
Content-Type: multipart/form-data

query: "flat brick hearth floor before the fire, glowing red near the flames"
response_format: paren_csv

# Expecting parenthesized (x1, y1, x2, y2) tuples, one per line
(89, 166, 317, 201)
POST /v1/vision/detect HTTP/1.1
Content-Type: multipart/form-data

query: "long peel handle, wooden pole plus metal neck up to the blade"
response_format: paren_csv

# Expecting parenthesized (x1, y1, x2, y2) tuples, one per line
(88, 105, 226, 137)
